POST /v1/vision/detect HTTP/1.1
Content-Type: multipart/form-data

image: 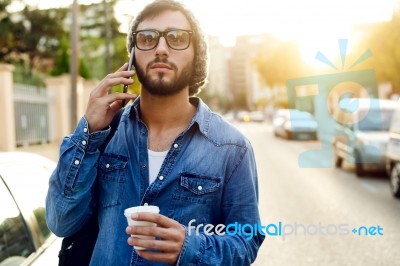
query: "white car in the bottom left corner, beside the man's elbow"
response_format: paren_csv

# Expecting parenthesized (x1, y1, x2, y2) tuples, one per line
(0, 152, 61, 266)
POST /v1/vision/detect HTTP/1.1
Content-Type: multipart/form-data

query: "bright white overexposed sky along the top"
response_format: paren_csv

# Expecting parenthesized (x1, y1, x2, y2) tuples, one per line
(7, 0, 400, 62)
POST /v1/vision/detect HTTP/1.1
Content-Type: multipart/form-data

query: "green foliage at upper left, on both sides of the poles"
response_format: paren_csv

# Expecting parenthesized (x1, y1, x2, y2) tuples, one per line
(0, 0, 140, 85)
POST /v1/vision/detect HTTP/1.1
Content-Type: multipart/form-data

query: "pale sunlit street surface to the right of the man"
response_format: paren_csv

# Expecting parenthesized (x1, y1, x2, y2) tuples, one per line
(236, 123, 400, 266)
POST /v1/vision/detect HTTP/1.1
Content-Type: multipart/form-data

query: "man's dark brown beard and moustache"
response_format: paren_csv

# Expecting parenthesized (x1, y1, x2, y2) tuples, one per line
(136, 58, 193, 96)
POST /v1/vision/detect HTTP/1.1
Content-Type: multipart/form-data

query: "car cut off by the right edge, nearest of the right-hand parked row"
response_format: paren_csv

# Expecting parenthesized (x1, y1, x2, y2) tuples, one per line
(386, 103, 400, 198)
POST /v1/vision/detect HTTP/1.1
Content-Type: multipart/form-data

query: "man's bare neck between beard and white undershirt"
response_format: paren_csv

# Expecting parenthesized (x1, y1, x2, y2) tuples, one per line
(140, 89, 196, 131)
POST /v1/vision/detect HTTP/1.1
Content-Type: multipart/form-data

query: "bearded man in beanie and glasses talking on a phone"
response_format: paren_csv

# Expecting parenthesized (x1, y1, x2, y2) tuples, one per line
(47, 0, 264, 266)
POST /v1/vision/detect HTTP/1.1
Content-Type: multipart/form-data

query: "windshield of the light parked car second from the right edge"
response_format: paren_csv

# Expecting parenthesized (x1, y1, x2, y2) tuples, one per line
(358, 109, 394, 131)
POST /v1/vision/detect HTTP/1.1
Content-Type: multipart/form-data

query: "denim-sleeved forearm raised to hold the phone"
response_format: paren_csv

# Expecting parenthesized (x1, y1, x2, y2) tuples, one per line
(46, 118, 109, 236)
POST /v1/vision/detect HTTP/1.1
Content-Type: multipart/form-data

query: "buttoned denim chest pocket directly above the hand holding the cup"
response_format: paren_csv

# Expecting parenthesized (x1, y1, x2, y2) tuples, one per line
(173, 172, 222, 204)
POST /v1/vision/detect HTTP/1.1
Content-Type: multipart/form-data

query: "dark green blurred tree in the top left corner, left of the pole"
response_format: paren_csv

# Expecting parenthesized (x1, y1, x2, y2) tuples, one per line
(0, 3, 67, 85)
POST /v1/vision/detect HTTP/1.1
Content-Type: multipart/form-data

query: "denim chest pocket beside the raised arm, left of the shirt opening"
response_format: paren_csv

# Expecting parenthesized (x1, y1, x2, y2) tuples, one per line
(98, 154, 128, 208)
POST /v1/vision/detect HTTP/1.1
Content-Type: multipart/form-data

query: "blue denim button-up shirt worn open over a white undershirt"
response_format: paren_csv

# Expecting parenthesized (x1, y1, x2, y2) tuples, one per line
(46, 98, 264, 266)
